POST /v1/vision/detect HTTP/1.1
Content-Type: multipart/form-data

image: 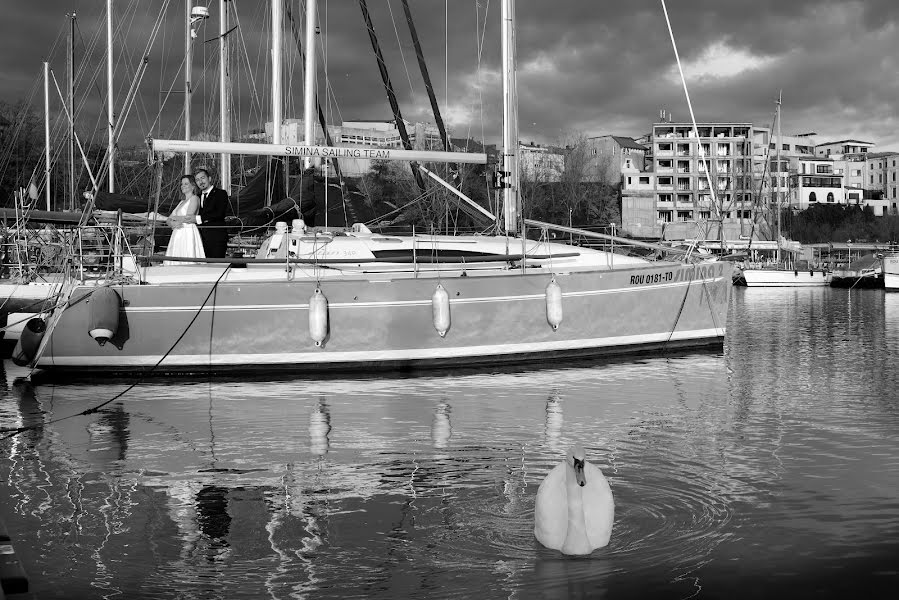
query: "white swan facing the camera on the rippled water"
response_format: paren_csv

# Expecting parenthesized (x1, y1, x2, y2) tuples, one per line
(534, 446, 615, 555)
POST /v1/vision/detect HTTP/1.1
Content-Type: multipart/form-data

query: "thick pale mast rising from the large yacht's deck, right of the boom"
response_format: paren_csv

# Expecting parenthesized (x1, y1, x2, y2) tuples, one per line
(502, 0, 519, 233)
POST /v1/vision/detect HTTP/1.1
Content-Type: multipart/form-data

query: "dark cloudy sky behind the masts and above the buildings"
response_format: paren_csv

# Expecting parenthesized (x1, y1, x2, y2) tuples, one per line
(0, 0, 899, 150)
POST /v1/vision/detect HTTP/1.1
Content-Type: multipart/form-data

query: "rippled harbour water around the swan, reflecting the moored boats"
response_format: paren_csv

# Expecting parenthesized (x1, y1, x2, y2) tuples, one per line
(0, 288, 899, 598)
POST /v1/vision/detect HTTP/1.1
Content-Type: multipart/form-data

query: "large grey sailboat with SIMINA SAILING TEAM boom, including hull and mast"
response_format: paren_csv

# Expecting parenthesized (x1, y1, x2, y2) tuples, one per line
(15, 0, 732, 376)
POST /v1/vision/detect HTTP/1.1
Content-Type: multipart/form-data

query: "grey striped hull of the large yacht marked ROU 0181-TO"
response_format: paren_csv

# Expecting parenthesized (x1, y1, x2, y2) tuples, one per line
(36, 262, 732, 375)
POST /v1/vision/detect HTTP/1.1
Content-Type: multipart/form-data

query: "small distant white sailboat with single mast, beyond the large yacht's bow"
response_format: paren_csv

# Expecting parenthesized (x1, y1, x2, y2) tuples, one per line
(742, 95, 831, 287)
